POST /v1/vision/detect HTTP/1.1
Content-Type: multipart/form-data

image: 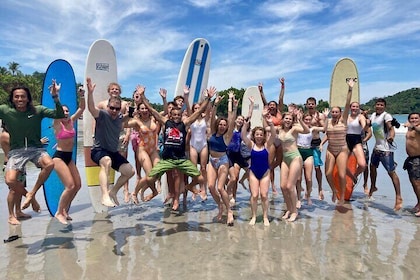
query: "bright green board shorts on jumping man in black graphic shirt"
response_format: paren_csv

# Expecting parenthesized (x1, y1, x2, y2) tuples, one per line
(149, 159, 200, 178)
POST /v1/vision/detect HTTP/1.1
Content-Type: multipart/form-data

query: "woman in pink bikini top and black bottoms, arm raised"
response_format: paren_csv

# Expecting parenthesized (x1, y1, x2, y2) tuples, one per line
(53, 88, 85, 225)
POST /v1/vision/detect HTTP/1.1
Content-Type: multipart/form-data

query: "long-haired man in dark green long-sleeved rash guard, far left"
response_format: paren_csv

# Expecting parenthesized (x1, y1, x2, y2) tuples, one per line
(0, 80, 64, 225)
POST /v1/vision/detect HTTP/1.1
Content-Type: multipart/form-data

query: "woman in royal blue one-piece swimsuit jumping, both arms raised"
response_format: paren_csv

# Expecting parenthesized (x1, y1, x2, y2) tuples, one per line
(241, 111, 276, 226)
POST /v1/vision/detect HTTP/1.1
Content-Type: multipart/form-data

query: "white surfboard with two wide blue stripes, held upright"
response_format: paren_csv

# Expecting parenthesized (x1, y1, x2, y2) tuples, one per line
(175, 38, 211, 106)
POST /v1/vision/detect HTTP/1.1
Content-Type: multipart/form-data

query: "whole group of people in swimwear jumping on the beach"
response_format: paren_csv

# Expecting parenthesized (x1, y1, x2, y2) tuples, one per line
(0, 75, 420, 226)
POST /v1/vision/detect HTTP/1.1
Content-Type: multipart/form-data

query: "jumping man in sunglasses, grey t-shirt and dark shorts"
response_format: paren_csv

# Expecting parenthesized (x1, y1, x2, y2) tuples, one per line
(87, 78, 134, 207)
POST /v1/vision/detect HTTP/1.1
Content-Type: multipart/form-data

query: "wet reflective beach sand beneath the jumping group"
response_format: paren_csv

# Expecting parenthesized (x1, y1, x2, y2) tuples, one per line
(0, 134, 420, 279)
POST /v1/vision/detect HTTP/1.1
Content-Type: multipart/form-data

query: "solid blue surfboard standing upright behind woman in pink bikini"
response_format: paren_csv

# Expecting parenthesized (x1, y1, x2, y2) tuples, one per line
(41, 59, 78, 216)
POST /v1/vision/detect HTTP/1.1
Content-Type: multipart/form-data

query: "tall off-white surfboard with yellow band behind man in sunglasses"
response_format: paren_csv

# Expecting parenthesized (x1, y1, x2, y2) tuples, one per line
(83, 40, 118, 213)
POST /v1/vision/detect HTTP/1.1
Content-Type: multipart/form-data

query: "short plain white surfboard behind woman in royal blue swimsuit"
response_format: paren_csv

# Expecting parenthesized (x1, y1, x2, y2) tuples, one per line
(242, 86, 264, 127)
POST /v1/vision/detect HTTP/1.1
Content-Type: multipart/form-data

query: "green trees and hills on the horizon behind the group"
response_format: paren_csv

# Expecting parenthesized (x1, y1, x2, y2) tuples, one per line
(0, 62, 420, 115)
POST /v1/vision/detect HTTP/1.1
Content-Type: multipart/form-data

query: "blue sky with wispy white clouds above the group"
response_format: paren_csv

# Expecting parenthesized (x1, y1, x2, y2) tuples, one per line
(0, 0, 420, 104)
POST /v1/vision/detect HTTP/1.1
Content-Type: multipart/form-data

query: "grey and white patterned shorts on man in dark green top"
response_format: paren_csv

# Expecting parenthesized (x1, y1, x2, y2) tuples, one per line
(6, 147, 49, 173)
